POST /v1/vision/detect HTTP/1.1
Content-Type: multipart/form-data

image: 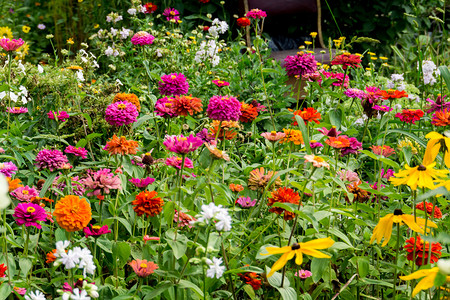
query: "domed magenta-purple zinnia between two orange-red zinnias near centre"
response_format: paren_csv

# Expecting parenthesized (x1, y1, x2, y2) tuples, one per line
(206, 95, 242, 121)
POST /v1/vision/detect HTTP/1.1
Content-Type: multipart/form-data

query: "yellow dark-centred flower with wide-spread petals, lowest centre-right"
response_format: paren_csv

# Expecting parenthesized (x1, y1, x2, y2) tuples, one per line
(260, 238, 334, 277)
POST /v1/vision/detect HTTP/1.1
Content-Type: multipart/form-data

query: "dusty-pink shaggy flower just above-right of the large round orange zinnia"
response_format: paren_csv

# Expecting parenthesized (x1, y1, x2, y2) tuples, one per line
(83, 169, 122, 196)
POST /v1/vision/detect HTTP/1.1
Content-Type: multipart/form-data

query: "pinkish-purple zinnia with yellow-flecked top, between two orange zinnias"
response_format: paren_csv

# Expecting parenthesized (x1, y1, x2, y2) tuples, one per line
(105, 101, 139, 126)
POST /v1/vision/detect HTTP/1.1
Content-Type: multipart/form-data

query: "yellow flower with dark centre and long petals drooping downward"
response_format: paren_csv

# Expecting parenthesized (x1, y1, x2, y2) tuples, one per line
(370, 209, 437, 247)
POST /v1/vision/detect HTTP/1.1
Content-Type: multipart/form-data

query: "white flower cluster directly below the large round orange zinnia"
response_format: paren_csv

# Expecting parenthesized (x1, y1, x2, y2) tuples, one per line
(54, 241, 95, 277)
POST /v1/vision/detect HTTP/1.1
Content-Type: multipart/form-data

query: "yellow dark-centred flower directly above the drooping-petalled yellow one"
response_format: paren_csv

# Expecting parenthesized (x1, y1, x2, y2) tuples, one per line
(389, 161, 448, 190)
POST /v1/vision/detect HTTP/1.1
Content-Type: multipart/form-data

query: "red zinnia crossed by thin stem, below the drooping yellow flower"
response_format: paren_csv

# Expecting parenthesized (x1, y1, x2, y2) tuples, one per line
(404, 235, 442, 266)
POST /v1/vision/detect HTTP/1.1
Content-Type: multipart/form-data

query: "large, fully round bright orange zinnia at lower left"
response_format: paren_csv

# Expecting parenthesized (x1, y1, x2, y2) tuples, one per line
(53, 195, 92, 232)
